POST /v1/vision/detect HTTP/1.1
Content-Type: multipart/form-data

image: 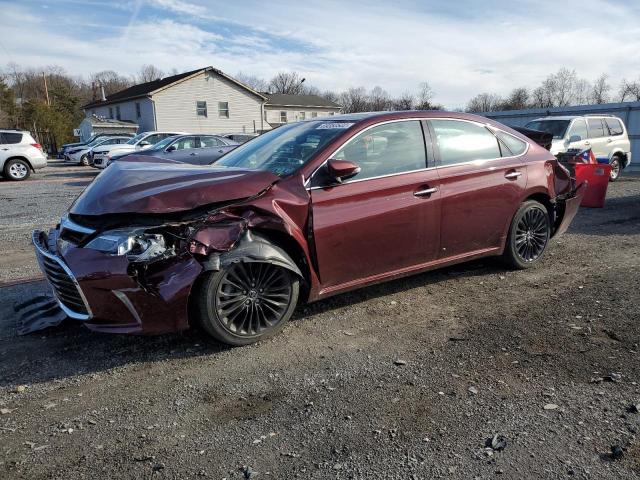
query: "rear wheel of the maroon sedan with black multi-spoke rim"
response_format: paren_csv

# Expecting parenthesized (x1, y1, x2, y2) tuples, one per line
(503, 200, 551, 269)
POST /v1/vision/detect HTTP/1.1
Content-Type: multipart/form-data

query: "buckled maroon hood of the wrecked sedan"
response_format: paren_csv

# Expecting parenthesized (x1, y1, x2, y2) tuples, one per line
(69, 157, 279, 215)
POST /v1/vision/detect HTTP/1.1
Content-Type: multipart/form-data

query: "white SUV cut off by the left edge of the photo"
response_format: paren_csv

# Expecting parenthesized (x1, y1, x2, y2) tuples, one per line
(0, 130, 47, 180)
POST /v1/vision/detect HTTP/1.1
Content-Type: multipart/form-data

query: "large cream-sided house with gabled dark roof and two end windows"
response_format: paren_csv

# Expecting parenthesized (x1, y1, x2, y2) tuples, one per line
(83, 67, 270, 133)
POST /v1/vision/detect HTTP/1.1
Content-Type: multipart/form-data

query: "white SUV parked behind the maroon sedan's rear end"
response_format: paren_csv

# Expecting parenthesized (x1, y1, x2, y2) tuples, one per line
(525, 115, 631, 181)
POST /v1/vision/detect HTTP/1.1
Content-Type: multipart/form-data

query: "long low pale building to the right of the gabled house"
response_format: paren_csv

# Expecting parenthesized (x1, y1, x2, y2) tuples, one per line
(264, 93, 341, 127)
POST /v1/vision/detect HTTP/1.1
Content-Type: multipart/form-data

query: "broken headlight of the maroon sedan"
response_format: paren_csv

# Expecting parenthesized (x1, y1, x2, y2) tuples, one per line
(85, 230, 167, 262)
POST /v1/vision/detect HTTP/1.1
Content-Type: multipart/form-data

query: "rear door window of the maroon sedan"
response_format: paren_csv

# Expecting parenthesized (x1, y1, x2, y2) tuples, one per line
(430, 120, 501, 165)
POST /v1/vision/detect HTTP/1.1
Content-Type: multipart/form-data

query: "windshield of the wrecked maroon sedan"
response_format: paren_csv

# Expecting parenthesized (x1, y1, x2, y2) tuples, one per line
(215, 121, 353, 177)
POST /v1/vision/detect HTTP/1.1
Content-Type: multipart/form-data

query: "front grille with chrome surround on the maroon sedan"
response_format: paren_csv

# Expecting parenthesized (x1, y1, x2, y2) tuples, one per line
(32, 230, 91, 320)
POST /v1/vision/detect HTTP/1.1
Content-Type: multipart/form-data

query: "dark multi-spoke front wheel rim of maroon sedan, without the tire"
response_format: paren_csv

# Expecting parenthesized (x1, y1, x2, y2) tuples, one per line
(214, 262, 292, 337)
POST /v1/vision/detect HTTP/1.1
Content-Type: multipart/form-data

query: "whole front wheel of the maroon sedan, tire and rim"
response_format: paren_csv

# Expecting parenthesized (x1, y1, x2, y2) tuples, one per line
(194, 262, 300, 346)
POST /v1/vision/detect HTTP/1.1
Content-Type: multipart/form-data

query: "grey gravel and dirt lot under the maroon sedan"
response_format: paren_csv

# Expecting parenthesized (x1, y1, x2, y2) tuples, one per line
(0, 162, 640, 480)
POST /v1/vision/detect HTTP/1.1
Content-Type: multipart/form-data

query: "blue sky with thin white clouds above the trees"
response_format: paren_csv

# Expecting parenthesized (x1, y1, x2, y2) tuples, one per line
(0, 0, 640, 108)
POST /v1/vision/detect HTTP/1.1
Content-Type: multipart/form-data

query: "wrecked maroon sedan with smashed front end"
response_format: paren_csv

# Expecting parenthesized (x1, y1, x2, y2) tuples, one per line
(33, 112, 584, 345)
